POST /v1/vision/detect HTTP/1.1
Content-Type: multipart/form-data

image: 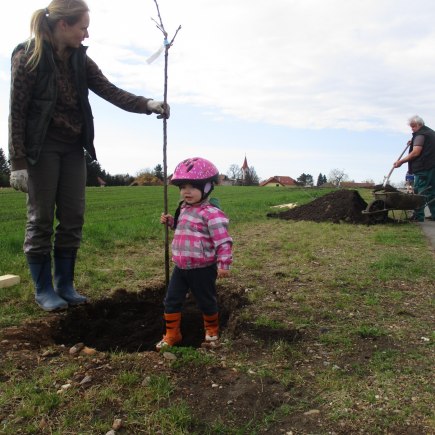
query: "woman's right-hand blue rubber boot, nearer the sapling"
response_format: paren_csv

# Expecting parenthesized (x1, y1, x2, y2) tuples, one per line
(54, 248, 88, 305)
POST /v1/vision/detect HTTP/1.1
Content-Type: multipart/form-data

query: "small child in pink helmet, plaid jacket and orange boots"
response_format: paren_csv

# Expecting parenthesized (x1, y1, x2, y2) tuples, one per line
(156, 157, 233, 350)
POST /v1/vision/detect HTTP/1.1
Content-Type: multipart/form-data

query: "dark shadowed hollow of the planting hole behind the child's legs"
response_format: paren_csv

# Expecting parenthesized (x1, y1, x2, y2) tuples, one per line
(53, 288, 245, 353)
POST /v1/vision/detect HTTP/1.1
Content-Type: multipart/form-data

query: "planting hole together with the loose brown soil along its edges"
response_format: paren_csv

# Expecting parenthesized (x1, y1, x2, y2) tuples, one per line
(2, 288, 301, 353)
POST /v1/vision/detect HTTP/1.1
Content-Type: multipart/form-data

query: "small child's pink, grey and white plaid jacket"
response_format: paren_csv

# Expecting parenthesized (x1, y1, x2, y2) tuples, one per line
(169, 201, 233, 269)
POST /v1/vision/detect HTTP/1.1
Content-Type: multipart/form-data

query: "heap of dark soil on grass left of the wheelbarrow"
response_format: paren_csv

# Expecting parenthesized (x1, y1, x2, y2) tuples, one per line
(267, 189, 368, 224)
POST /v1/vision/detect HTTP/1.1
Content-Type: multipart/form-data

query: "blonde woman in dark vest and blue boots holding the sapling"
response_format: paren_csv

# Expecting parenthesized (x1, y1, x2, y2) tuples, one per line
(9, 0, 169, 311)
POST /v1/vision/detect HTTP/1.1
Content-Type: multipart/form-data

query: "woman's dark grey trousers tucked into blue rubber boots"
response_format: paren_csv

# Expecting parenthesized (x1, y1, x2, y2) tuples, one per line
(24, 142, 86, 255)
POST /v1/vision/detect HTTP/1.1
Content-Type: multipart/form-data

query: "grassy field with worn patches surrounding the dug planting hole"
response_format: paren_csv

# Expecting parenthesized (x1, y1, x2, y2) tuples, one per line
(0, 186, 435, 435)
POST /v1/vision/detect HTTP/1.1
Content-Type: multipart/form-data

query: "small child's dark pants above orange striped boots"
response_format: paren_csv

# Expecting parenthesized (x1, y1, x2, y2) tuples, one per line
(164, 264, 218, 316)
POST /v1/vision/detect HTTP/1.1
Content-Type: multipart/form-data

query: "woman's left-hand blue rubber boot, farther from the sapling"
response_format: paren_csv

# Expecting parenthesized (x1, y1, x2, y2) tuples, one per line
(26, 254, 68, 311)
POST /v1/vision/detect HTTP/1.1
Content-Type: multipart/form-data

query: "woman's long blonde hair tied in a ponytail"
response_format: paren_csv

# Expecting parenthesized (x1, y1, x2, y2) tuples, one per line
(27, 0, 89, 70)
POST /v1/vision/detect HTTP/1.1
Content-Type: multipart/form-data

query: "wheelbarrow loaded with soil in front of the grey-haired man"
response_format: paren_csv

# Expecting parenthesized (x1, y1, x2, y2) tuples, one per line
(362, 190, 427, 224)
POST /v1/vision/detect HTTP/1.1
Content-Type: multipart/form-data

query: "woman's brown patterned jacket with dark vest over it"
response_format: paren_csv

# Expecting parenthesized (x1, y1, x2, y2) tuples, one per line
(9, 42, 151, 170)
